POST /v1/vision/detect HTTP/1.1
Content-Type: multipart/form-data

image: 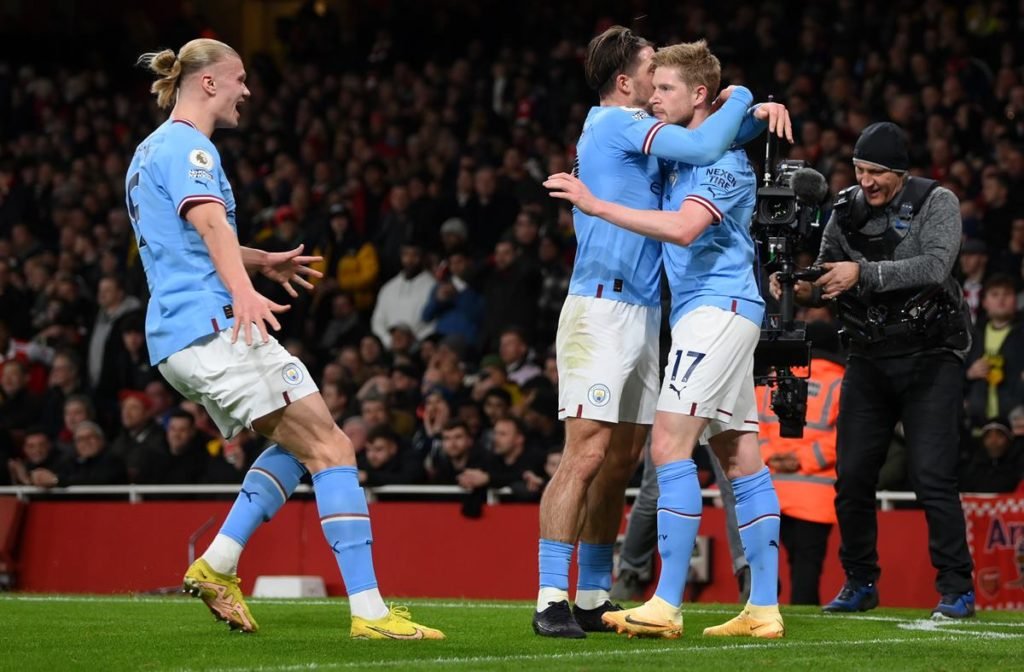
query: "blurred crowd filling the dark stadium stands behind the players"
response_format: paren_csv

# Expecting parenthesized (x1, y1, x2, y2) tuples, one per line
(0, 0, 1024, 500)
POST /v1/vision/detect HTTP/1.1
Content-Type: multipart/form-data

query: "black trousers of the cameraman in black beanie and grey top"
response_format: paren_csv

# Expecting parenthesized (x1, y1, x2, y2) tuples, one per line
(836, 352, 973, 593)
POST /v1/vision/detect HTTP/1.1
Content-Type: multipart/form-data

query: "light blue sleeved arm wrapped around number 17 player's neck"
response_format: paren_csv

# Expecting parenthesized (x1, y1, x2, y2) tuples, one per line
(642, 86, 754, 166)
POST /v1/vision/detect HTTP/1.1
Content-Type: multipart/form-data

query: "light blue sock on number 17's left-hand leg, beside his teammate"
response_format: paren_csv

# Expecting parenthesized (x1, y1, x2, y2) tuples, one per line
(654, 460, 702, 606)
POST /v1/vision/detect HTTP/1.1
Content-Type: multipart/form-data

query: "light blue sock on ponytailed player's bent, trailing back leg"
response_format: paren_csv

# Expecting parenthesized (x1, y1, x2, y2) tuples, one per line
(220, 444, 306, 546)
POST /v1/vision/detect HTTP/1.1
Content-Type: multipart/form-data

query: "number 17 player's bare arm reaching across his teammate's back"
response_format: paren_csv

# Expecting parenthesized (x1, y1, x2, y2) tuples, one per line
(544, 173, 714, 245)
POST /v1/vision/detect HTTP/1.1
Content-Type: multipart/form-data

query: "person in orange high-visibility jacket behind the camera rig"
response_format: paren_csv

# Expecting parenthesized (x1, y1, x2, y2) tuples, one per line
(757, 322, 846, 604)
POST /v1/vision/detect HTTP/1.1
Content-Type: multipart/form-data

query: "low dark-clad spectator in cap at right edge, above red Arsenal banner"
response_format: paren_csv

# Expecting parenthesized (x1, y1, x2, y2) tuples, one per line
(959, 418, 1024, 493)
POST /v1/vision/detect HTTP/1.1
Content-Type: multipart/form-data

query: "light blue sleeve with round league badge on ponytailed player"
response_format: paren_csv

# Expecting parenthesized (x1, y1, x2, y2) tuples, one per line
(163, 138, 227, 218)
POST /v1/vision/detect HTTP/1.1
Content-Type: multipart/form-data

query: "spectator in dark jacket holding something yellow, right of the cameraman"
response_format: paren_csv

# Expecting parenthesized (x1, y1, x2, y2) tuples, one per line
(967, 276, 1024, 427)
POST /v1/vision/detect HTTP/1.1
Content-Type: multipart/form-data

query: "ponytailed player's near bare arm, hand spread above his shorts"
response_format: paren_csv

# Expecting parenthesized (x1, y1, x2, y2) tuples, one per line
(185, 202, 291, 345)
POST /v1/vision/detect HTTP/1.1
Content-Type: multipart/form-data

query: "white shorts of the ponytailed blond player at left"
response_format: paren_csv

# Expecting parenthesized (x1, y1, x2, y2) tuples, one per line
(159, 327, 318, 438)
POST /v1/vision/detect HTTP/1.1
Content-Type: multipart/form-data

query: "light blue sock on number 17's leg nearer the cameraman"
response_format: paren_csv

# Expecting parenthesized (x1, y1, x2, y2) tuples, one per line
(732, 467, 779, 606)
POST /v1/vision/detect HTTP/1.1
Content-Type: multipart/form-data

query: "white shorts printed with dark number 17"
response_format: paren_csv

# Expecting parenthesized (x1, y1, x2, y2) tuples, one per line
(657, 305, 761, 442)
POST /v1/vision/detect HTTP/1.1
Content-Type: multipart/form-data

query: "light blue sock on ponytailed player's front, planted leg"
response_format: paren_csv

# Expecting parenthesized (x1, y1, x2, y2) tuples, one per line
(313, 467, 377, 595)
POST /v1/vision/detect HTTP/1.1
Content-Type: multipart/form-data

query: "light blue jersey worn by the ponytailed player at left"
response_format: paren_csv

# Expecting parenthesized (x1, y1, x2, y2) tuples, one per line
(125, 120, 236, 365)
